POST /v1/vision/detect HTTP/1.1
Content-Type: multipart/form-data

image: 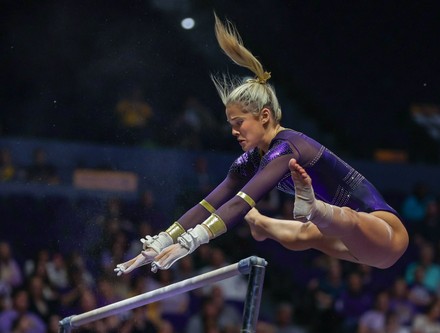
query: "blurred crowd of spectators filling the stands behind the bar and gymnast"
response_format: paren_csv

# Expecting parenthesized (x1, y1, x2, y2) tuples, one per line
(0, 143, 440, 333)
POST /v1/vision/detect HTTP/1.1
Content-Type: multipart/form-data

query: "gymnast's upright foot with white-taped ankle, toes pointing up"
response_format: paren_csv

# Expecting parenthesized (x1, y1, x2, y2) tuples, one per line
(289, 158, 316, 222)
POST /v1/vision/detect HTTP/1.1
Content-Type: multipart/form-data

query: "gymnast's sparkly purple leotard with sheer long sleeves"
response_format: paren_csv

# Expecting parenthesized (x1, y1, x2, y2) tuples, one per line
(178, 129, 397, 232)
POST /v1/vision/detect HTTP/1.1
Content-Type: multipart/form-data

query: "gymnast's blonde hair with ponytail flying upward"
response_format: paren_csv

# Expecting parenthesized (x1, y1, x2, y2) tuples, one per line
(211, 14, 281, 123)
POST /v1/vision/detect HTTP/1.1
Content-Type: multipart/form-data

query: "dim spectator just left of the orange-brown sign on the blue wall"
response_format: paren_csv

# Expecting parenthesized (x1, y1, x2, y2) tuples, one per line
(26, 148, 60, 185)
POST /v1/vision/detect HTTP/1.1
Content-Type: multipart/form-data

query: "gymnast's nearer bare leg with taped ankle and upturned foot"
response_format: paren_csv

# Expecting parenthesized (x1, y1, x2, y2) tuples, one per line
(289, 159, 408, 268)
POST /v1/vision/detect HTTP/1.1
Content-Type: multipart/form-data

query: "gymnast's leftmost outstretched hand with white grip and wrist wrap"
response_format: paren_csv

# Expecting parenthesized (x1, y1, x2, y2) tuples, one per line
(114, 232, 173, 276)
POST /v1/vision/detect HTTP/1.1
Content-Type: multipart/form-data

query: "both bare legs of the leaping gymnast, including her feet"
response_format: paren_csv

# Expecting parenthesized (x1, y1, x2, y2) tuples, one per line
(246, 159, 408, 268)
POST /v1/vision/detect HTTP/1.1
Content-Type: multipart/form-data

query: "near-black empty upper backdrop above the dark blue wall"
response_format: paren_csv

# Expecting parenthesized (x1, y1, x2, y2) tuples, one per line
(0, 0, 440, 162)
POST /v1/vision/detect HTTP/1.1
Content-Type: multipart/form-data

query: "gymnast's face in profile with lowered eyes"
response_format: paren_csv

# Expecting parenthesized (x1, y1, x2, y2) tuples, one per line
(226, 104, 267, 151)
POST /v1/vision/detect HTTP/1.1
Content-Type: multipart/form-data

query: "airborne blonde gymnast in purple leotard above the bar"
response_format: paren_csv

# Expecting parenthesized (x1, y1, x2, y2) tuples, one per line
(115, 15, 408, 275)
